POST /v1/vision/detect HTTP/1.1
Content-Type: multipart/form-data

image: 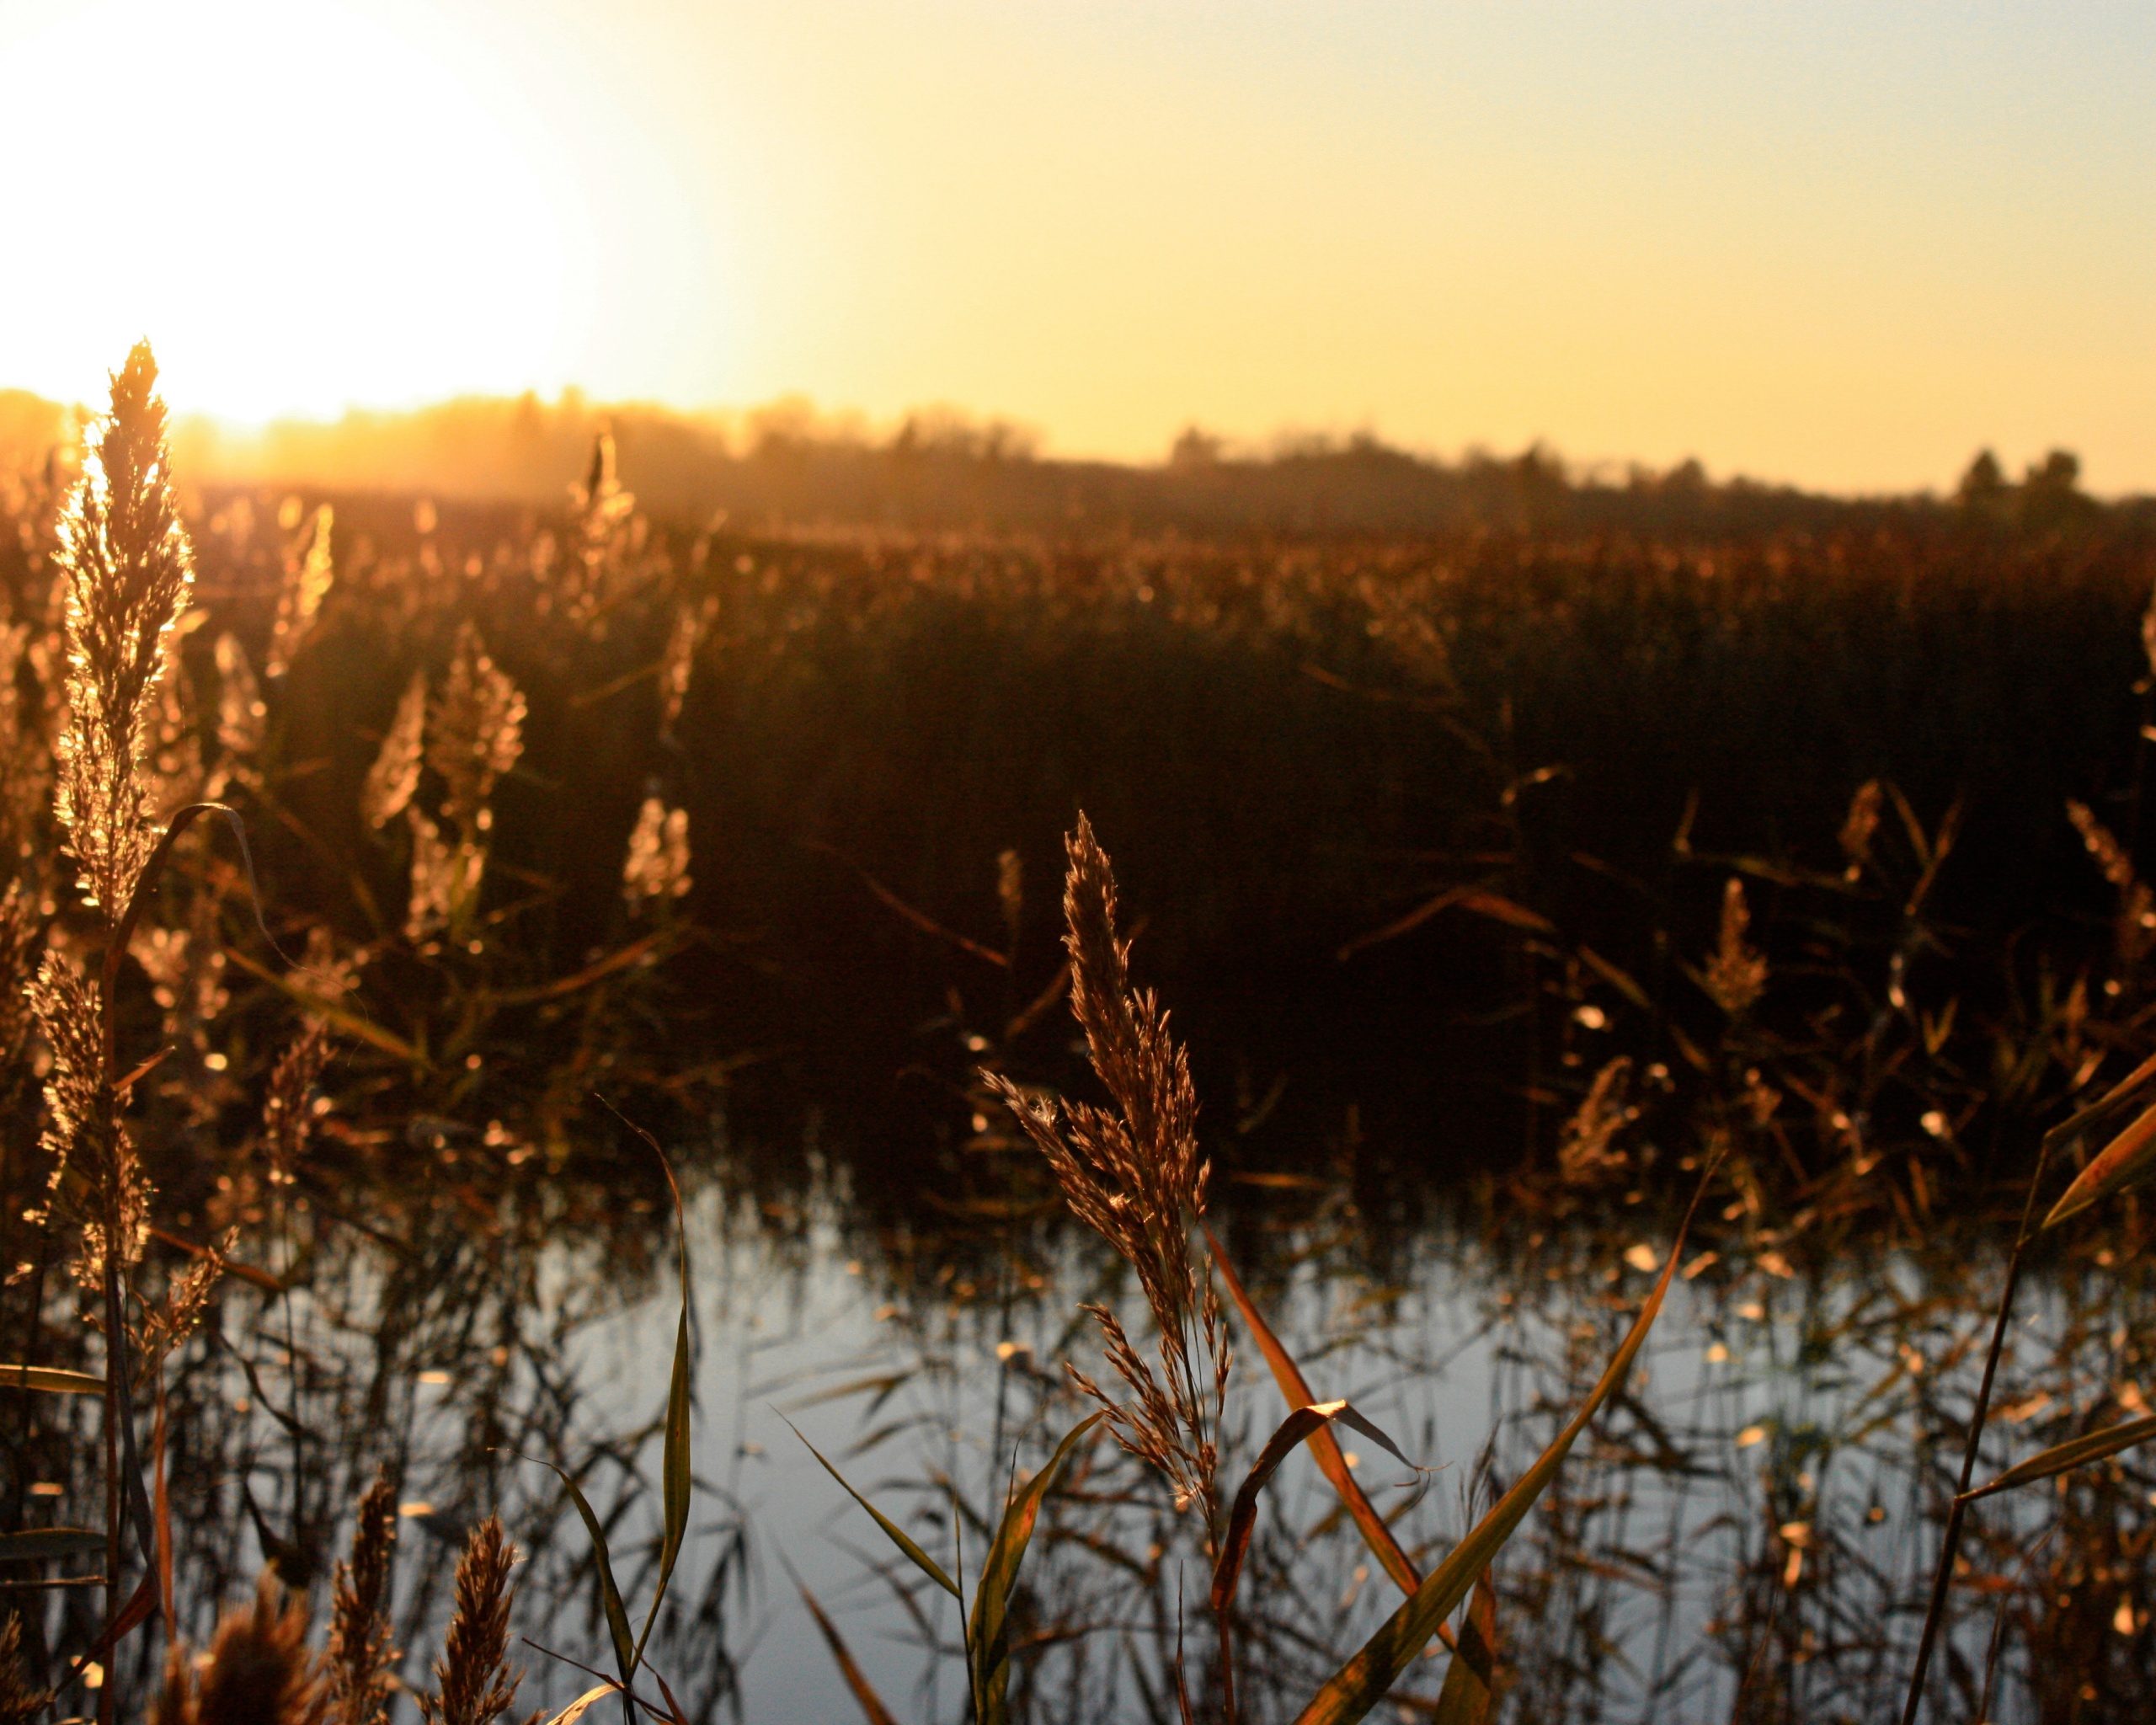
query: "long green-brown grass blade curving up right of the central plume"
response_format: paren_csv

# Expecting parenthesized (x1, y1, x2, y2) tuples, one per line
(1296, 1156, 1721, 1725)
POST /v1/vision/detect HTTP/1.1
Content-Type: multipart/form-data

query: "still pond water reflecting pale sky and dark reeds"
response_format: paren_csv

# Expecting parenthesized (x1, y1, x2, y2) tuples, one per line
(11, 1112, 2156, 1721)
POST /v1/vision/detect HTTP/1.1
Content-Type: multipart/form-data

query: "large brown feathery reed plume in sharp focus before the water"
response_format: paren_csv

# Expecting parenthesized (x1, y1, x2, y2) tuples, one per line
(981, 815, 1231, 1529)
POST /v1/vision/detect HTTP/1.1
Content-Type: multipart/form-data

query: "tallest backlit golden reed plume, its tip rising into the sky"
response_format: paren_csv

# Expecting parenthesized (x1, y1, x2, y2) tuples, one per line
(56, 340, 194, 916)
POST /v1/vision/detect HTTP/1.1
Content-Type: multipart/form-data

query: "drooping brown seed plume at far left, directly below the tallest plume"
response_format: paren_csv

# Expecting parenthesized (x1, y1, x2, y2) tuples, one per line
(30, 953, 151, 1324)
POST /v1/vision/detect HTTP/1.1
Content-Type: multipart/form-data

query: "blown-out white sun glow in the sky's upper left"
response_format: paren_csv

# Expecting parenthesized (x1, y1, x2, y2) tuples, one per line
(0, 0, 582, 419)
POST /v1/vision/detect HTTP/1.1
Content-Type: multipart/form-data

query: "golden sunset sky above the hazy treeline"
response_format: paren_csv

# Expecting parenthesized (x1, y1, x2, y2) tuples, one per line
(0, 0, 2156, 494)
